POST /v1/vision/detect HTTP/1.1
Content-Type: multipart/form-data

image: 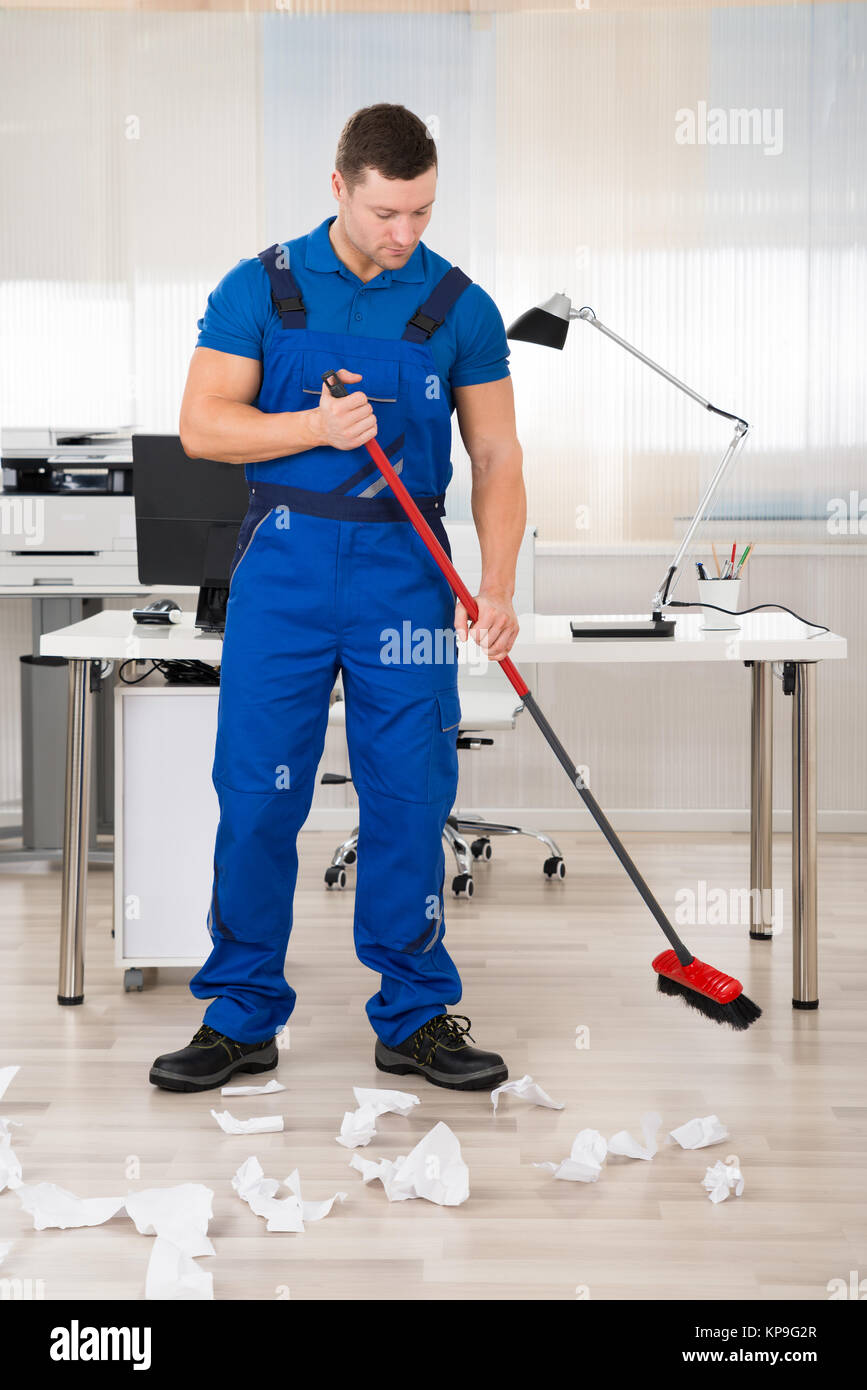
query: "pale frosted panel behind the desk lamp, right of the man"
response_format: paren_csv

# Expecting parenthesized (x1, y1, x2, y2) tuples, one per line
(497, 4, 867, 543)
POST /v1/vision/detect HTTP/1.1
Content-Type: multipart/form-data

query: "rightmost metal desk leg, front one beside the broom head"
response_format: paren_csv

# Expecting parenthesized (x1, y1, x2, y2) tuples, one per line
(792, 662, 818, 1009)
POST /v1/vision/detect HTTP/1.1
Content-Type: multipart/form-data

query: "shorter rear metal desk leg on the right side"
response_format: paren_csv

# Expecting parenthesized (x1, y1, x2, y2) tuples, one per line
(750, 662, 774, 941)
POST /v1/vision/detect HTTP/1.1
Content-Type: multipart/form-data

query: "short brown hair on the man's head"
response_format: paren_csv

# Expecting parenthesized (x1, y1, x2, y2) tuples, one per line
(335, 101, 436, 193)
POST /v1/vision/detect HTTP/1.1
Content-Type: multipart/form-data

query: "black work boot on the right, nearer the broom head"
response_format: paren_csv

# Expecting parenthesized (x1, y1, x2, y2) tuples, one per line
(374, 1013, 509, 1091)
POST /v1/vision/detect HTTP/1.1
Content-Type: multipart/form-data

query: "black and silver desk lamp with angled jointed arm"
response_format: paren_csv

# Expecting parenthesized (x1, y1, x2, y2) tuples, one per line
(506, 295, 749, 638)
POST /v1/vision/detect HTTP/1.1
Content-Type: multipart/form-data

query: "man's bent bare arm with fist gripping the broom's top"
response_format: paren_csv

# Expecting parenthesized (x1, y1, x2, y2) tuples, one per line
(179, 348, 377, 463)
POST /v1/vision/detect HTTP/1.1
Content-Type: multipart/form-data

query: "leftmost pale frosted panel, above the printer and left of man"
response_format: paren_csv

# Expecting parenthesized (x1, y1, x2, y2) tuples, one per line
(0, 10, 261, 431)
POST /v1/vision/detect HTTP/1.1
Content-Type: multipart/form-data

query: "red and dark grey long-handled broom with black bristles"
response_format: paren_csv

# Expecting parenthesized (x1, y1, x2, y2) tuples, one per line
(322, 371, 761, 1031)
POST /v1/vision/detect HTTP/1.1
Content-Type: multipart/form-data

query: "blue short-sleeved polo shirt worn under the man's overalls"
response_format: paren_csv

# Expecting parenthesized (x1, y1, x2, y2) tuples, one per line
(196, 217, 509, 410)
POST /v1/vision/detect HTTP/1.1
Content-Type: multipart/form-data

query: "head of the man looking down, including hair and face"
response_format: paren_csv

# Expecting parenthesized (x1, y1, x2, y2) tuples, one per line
(331, 103, 436, 270)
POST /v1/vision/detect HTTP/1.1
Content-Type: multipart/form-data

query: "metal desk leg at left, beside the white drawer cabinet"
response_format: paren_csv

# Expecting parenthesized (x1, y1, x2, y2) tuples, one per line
(57, 662, 93, 1004)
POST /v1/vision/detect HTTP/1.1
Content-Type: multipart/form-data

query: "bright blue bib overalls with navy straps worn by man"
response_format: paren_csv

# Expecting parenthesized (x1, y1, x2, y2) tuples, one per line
(190, 239, 471, 1045)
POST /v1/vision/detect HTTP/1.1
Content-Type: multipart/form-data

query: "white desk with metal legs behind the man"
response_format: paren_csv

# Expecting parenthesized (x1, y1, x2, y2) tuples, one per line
(40, 612, 846, 1009)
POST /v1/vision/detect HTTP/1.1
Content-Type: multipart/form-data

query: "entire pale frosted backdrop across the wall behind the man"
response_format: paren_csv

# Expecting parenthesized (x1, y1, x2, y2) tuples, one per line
(0, 3, 867, 545)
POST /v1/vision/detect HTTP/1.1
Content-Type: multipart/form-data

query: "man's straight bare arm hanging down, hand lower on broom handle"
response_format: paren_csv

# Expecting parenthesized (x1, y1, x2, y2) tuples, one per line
(454, 377, 527, 660)
